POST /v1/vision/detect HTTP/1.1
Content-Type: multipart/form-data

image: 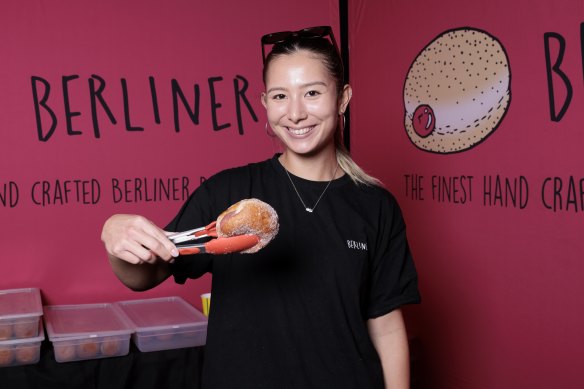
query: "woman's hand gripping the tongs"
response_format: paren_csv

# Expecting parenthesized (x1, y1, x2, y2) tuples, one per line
(101, 214, 178, 264)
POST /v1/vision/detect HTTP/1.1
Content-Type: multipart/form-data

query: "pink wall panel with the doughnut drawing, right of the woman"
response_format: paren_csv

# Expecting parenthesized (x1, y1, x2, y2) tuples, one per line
(349, 0, 584, 389)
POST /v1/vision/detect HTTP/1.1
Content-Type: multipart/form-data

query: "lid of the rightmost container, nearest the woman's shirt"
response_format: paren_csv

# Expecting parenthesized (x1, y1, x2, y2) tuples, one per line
(116, 296, 207, 331)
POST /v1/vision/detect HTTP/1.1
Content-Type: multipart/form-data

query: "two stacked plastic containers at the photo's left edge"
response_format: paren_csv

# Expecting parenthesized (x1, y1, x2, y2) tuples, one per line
(0, 288, 45, 367)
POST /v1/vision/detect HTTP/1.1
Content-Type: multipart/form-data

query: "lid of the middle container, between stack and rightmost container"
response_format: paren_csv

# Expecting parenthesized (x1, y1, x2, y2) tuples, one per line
(44, 303, 132, 339)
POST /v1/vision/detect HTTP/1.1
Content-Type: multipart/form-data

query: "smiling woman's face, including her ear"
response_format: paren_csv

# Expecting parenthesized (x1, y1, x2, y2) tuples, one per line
(262, 51, 350, 156)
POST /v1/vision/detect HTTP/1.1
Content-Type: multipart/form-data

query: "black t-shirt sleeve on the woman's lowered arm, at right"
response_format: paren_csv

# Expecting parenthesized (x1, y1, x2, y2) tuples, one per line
(367, 194, 421, 318)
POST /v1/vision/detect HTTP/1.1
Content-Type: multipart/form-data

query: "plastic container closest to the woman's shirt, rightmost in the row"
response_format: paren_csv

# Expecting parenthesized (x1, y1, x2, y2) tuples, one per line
(116, 296, 207, 352)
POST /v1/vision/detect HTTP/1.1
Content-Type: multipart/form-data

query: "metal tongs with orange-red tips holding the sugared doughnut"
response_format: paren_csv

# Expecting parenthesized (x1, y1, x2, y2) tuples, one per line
(168, 221, 260, 255)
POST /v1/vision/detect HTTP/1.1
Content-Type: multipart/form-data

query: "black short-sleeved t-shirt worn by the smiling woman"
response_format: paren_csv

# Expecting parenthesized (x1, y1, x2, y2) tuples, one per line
(167, 155, 420, 389)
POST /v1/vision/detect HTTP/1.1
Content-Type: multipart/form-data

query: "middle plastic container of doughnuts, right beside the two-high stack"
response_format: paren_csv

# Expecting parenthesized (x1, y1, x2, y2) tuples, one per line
(44, 304, 132, 362)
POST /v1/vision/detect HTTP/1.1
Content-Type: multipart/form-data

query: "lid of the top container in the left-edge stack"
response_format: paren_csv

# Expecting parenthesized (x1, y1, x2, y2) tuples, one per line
(0, 288, 43, 320)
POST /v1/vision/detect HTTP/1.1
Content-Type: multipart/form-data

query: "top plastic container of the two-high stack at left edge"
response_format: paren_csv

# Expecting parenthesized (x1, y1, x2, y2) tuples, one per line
(0, 288, 43, 342)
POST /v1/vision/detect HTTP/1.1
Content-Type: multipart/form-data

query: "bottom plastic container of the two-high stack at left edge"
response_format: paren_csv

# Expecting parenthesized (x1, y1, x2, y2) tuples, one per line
(0, 320, 45, 368)
